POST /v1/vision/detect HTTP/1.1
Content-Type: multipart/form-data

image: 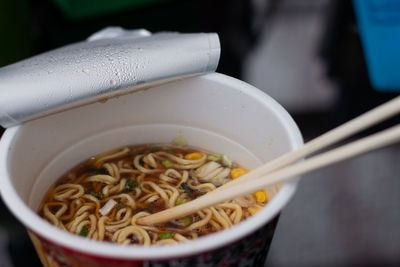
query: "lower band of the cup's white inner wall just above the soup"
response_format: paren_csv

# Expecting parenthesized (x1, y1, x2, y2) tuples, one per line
(28, 124, 264, 210)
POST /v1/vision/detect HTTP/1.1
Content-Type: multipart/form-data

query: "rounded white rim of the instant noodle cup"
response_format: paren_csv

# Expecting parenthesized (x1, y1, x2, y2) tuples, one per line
(0, 73, 303, 260)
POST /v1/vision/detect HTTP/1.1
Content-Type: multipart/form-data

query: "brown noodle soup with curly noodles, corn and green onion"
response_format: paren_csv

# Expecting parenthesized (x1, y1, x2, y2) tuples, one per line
(38, 145, 268, 245)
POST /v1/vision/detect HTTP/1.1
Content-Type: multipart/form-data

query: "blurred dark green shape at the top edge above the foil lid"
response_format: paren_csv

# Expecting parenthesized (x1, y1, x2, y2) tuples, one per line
(53, 0, 170, 20)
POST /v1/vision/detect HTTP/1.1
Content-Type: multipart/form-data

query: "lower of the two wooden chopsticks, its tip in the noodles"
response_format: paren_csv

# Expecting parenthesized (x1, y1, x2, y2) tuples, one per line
(136, 125, 400, 225)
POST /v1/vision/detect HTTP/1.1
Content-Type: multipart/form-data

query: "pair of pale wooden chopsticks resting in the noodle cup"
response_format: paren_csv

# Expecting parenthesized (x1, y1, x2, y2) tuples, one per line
(137, 96, 400, 225)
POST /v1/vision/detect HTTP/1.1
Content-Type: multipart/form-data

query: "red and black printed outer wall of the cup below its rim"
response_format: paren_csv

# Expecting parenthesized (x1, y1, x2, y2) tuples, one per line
(28, 216, 279, 267)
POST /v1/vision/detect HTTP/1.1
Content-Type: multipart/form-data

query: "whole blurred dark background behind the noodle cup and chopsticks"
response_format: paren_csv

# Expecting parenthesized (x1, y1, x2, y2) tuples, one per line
(0, 0, 400, 267)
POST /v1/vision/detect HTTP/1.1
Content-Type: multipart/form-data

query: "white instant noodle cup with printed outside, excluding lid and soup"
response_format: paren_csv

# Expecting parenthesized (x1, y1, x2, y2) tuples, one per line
(0, 73, 303, 266)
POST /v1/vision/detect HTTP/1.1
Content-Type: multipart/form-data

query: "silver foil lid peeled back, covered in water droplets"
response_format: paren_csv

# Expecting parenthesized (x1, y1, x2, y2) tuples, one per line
(0, 27, 220, 128)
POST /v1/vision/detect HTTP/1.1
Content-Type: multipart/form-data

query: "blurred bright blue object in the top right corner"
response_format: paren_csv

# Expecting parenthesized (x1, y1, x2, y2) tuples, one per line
(353, 0, 400, 92)
